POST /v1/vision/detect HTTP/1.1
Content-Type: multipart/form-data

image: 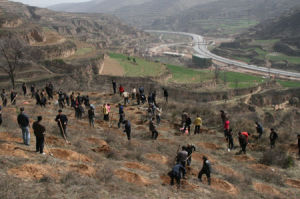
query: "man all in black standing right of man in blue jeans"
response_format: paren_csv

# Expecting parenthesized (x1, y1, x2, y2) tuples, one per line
(32, 116, 46, 155)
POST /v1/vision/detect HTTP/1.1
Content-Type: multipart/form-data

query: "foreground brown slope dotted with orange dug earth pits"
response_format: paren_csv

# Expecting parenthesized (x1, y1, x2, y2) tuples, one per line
(0, 72, 300, 199)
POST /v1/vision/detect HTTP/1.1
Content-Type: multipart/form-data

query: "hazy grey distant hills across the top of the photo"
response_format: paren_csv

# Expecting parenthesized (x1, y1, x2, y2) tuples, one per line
(51, 0, 299, 36)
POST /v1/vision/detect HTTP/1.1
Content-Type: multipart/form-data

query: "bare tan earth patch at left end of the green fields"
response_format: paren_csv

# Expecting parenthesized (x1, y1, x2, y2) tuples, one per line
(99, 56, 125, 76)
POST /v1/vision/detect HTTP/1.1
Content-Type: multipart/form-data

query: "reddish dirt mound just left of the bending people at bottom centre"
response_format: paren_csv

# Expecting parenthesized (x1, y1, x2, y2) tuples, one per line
(114, 169, 151, 186)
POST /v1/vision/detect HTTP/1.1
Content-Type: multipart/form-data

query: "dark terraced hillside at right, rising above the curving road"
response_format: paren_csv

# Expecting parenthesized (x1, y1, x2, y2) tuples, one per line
(214, 10, 300, 71)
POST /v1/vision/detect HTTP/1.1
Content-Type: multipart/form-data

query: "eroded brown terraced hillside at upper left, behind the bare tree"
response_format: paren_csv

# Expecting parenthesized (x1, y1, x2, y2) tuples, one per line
(0, 0, 148, 86)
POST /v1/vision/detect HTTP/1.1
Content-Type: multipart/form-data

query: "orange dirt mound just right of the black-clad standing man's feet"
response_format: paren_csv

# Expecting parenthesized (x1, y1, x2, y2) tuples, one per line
(50, 148, 92, 162)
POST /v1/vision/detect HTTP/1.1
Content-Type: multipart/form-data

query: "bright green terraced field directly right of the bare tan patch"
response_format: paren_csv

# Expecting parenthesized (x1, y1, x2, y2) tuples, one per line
(109, 53, 166, 77)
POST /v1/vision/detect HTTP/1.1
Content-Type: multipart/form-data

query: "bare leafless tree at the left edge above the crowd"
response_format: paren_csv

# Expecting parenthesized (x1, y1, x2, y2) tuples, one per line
(0, 37, 23, 89)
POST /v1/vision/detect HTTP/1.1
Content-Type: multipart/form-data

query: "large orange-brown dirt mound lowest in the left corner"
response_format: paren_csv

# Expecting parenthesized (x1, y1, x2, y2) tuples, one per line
(7, 164, 59, 180)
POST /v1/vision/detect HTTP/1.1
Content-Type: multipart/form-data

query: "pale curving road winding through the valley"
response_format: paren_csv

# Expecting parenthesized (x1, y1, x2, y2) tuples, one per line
(145, 30, 300, 78)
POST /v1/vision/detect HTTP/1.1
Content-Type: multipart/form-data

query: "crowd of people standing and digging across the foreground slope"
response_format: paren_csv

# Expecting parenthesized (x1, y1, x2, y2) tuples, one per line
(0, 80, 300, 190)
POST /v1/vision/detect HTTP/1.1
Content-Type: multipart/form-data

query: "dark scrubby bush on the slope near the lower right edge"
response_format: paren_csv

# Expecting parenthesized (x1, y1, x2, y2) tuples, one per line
(260, 149, 295, 169)
